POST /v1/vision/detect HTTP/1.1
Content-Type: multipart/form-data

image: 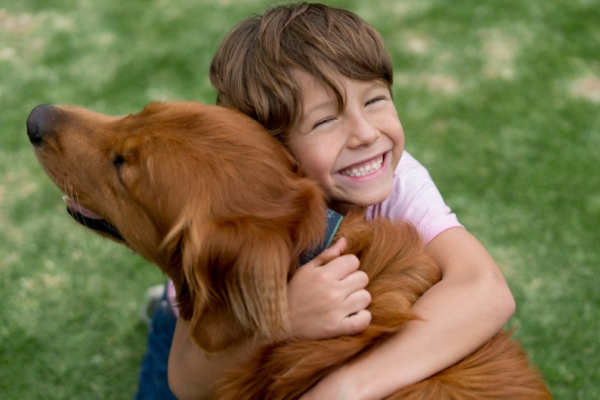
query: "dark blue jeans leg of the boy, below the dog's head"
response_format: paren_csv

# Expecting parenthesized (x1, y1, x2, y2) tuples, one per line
(135, 290, 177, 400)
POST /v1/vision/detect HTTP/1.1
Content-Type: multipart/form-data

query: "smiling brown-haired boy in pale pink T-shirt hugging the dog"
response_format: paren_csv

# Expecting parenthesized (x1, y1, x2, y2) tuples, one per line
(150, 3, 514, 399)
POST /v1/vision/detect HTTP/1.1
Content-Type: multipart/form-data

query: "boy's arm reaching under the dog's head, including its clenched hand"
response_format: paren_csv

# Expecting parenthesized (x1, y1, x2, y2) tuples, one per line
(168, 238, 371, 400)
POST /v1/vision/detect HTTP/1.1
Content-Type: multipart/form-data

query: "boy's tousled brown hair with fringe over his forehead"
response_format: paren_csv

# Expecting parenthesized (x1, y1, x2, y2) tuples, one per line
(210, 3, 393, 143)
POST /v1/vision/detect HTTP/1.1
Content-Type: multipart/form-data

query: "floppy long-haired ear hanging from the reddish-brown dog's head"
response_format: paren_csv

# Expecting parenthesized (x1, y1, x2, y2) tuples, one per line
(182, 217, 291, 353)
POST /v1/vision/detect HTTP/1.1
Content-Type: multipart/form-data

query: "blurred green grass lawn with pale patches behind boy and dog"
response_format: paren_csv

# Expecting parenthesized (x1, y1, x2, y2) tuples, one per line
(0, 0, 600, 400)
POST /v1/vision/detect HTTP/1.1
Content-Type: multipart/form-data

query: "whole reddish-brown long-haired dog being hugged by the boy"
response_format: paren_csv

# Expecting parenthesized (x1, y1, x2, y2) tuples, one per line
(27, 102, 551, 400)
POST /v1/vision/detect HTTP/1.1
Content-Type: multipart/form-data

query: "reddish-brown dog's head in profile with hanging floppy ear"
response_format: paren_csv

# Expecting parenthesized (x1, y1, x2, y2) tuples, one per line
(27, 103, 325, 352)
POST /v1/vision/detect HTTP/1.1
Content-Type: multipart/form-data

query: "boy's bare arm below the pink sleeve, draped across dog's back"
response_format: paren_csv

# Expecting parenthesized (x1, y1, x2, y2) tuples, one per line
(302, 227, 515, 400)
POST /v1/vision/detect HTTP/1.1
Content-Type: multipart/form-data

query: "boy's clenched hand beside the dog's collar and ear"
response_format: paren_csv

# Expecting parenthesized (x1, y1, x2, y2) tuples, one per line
(288, 238, 371, 339)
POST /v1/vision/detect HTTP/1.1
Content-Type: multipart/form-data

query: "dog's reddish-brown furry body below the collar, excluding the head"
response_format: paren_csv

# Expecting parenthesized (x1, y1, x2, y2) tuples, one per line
(216, 214, 551, 400)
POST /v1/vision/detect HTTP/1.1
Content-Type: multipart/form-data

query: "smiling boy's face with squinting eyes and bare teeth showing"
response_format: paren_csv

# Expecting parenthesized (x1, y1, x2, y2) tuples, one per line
(289, 71, 404, 211)
